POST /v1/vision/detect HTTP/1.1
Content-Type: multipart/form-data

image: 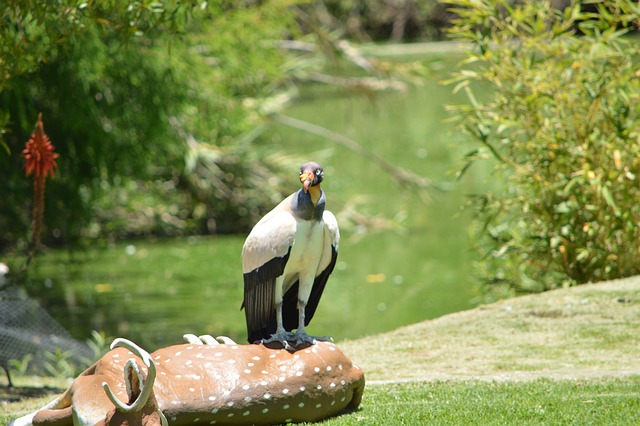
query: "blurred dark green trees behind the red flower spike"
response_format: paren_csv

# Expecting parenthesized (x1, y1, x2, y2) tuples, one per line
(0, 0, 302, 247)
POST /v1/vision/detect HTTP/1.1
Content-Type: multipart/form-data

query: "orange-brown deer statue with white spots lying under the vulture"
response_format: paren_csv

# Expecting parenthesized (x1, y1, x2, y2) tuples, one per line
(10, 334, 365, 426)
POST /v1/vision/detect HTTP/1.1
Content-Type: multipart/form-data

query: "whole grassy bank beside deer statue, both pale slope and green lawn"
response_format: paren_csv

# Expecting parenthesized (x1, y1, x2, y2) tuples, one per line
(0, 277, 640, 426)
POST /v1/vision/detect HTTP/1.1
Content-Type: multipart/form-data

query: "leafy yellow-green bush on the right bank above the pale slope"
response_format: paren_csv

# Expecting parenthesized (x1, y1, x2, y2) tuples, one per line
(451, 0, 640, 296)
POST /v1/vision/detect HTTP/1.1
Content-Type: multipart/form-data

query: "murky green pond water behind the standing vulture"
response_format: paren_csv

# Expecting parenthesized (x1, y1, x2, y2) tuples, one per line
(23, 51, 482, 350)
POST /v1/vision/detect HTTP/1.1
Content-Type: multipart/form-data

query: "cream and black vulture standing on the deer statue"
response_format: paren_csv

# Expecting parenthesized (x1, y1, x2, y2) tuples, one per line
(241, 161, 340, 351)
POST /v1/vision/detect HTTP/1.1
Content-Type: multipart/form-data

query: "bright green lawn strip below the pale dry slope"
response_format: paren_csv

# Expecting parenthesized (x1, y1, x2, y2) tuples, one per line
(323, 376, 640, 426)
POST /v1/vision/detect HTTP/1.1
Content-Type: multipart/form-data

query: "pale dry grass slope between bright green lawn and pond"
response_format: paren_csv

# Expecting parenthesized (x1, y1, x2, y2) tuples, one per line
(340, 277, 640, 384)
